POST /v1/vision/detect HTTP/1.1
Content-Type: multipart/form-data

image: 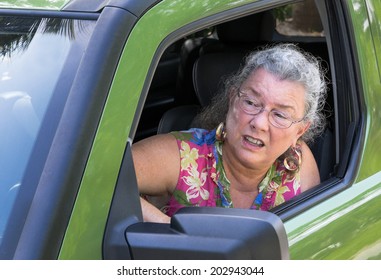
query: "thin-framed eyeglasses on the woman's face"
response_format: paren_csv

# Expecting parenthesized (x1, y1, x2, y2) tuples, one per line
(237, 90, 304, 128)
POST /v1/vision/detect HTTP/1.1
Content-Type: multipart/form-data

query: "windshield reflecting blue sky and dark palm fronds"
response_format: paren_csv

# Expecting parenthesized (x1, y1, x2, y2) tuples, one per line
(0, 16, 94, 249)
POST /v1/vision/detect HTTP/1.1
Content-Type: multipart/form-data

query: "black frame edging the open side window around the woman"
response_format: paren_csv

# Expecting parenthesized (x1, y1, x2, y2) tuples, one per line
(130, 0, 365, 221)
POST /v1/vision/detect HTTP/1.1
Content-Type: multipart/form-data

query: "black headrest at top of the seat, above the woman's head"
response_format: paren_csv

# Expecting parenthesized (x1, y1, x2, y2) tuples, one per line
(216, 11, 275, 44)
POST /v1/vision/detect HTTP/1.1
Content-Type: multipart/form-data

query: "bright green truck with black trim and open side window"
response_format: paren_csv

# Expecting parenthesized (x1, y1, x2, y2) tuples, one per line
(0, 0, 381, 260)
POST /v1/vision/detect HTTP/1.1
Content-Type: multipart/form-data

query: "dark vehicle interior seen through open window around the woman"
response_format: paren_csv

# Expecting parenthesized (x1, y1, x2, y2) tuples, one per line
(134, 1, 336, 186)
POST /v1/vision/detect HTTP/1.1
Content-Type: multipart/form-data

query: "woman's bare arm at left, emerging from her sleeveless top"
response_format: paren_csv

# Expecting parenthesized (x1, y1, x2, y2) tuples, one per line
(132, 134, 180, 222)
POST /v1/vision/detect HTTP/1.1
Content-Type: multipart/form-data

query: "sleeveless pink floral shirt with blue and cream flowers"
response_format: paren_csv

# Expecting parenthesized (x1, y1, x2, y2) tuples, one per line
(163, 129, 300, 216)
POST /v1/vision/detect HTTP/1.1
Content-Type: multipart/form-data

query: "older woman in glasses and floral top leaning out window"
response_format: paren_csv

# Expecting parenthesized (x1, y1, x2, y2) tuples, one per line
(133, 44, 326, 222)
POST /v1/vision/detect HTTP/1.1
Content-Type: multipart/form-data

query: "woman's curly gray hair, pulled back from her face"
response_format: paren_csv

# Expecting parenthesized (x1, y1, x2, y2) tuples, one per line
(194, 44, 326, 142)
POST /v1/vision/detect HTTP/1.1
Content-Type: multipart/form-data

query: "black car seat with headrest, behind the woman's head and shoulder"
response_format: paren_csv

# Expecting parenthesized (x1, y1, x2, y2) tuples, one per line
(157, 12, 275, 134)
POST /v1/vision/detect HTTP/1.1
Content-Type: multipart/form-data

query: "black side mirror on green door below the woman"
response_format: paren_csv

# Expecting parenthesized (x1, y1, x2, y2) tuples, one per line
(125, 207, 289, 260)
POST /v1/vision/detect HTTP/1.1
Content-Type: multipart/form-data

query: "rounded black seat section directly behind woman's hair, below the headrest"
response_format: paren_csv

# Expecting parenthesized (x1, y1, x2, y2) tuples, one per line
(193, 52, 244, 107)
